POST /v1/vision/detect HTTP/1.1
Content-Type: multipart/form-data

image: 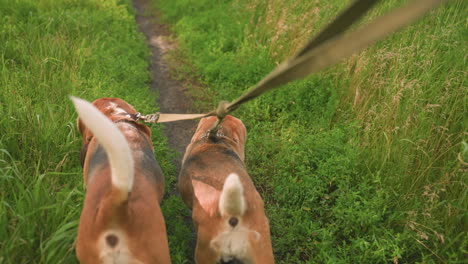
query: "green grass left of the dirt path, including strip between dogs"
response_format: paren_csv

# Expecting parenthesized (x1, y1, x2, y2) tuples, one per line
(0, 0, 189, 263)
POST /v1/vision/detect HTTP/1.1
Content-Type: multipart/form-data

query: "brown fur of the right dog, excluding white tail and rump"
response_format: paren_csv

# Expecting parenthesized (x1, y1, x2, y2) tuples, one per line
(179, 116, 274, 264)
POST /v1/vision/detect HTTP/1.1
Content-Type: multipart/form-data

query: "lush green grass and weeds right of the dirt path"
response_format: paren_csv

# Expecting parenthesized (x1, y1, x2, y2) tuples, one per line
(154, 0, 468, 263)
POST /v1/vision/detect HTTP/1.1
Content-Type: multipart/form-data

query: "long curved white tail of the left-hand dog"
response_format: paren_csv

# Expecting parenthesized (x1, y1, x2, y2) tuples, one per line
(70, 96, 134, 201)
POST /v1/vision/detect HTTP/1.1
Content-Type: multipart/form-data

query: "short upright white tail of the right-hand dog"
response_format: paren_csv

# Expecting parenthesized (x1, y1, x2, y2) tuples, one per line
(219, 173, 246, 216)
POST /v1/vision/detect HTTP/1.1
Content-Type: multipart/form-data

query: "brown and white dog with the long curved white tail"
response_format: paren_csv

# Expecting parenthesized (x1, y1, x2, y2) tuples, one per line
(71, 97, 170, 264)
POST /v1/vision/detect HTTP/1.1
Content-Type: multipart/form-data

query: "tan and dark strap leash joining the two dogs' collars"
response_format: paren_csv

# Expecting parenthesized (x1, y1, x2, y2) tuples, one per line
(138, 0, 447, 124)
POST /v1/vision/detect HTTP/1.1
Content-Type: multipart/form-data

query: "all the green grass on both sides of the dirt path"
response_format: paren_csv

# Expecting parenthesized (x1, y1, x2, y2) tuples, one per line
(0, 0, 468, 264)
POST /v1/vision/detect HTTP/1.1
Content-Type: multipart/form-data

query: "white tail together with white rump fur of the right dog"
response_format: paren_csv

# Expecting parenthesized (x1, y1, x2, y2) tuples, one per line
(210, 173, 260, 263)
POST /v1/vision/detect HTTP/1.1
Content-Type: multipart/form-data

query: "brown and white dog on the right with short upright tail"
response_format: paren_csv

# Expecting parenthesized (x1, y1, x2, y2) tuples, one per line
(179, 116, 274, 264)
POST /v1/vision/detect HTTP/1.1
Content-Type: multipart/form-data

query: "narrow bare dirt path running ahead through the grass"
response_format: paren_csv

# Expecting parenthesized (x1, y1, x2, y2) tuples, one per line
(133, 0, 197, 173)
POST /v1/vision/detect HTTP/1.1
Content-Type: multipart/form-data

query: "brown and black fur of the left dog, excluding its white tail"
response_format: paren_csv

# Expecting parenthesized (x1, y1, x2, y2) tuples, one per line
(76, 98, 170, 263)
